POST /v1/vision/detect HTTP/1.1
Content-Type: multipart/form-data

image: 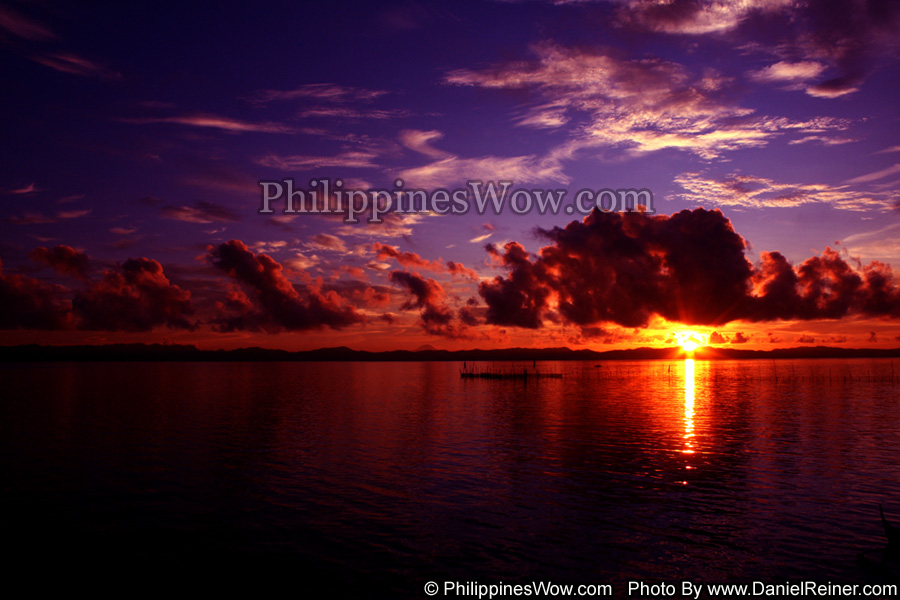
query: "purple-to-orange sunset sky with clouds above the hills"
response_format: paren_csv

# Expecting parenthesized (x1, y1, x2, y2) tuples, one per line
(0, 0, 900, 350)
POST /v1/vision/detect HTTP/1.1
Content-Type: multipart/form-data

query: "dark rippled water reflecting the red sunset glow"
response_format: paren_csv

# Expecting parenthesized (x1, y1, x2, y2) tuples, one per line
(0, 360, 900, 598)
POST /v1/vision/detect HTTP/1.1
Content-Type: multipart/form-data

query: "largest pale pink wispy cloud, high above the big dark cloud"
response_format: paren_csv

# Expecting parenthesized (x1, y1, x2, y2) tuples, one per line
(445, 43, 839, 162)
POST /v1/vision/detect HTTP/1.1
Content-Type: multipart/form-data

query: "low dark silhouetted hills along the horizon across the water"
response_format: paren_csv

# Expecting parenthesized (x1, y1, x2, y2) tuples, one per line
(0, 344, 900, 362)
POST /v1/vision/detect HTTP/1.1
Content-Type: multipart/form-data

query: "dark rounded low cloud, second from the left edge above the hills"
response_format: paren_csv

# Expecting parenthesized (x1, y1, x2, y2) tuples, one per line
(72, 258, 195, 331)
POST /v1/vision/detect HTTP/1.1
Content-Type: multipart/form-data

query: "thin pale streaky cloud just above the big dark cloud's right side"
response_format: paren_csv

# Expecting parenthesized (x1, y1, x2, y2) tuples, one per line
(675, 173, 895, 211)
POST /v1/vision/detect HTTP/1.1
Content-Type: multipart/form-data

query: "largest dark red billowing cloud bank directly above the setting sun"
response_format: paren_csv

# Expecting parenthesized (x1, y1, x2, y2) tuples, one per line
(479, 208, 900, 329)
